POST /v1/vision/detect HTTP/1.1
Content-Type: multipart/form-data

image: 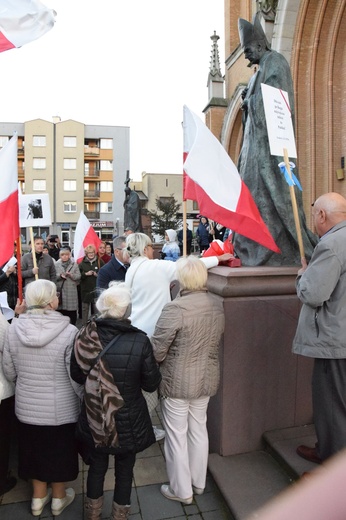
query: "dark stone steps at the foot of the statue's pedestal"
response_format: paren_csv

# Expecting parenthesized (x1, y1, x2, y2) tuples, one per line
(208, 425, 318, 520)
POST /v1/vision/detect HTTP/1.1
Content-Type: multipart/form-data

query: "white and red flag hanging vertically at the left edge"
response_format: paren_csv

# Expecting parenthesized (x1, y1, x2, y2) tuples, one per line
(0, 134, 19, 267)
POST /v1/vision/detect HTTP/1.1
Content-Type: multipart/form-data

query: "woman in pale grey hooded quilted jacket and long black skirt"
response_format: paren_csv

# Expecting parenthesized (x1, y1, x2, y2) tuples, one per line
(3, 280, 79, 516)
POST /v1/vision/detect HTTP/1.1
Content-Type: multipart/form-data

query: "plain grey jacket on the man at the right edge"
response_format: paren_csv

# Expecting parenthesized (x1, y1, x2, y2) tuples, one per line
(293, 220, 346, 359)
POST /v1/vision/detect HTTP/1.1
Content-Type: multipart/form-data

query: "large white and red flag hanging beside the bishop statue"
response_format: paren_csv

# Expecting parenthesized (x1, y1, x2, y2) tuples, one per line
(183, 106, 280, 253)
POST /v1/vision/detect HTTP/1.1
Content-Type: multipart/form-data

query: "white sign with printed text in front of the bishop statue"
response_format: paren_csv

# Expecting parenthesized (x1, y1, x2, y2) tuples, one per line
(261, 83, 297, 157)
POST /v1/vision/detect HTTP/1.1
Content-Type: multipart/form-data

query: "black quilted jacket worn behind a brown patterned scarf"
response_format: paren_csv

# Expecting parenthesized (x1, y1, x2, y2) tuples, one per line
(71, 318, 161, 453)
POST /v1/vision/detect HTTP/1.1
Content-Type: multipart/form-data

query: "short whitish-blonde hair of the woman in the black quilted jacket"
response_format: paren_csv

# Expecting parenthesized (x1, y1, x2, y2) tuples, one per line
(96, 282, 131, 319)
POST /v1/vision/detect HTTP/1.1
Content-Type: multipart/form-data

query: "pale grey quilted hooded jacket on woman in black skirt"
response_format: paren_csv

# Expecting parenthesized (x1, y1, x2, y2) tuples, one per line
(3, 311, 79, 426)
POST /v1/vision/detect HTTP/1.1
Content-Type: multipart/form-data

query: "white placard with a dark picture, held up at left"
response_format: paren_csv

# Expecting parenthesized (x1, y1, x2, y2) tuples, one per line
(19, 192, 52, 227)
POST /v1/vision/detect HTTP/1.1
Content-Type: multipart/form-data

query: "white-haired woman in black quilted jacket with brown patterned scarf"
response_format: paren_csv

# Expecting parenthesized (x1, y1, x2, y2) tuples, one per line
(71, 282, 161, 520)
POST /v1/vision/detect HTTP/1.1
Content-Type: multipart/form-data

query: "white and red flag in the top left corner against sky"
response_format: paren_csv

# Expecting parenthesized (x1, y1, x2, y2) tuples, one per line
(0, 0, 56, 52)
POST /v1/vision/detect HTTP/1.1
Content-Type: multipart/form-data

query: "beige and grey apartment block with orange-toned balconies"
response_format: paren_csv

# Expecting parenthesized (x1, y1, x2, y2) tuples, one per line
(0, 117, 130, 246)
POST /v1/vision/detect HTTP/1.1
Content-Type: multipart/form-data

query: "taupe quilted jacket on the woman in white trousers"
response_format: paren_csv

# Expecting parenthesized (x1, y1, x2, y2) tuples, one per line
(151, 290, 225, 399)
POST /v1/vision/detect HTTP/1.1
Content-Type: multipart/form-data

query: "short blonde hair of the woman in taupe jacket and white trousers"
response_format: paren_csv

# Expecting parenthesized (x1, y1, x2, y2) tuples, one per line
(175, 255, 208, 291)
